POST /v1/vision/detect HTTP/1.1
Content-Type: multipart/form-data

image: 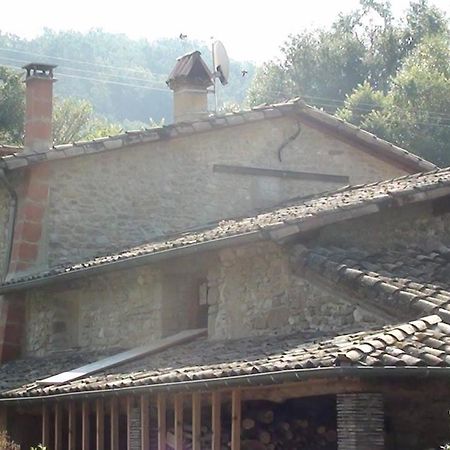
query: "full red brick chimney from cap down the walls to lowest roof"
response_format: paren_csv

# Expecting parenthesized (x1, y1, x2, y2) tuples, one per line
(0, 63, 56, 363)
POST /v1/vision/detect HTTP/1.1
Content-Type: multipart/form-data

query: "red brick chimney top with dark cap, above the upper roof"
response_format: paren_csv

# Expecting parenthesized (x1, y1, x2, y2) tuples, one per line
(23, 63, 56, 151)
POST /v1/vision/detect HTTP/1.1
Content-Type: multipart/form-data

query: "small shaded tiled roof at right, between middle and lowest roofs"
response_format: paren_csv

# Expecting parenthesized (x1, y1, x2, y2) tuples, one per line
(305, 245, 450, 322)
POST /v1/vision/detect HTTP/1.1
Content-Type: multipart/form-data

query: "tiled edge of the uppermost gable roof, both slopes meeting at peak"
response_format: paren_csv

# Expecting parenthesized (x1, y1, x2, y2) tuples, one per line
(0, 99, 436, 173)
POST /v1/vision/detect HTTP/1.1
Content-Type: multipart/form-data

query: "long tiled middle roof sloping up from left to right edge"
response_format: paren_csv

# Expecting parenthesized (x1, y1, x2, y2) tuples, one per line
(0, 168, 450, 293)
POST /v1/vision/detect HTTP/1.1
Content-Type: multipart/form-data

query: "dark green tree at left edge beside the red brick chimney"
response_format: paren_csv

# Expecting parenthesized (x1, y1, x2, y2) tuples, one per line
(0, 67, 24, 144)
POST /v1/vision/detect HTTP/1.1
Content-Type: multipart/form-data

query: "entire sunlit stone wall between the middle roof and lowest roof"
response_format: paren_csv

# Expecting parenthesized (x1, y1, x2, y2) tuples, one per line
(25, 239, 383, 355)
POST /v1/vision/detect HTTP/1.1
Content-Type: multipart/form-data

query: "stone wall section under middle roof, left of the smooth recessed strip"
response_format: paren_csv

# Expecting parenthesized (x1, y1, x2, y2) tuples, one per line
(24, 268, 162, 355)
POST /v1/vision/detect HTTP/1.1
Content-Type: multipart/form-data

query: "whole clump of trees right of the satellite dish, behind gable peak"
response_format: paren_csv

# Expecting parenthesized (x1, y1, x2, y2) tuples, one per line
(248, 0, 450, 165)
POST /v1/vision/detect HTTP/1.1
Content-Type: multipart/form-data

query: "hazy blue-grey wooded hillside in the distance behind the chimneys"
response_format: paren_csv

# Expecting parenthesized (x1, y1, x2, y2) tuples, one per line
(0, 29, 255, 123)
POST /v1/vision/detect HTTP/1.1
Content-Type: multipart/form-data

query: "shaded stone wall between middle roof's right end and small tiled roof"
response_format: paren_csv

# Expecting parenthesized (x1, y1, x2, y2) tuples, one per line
(314, 198, 450, 251)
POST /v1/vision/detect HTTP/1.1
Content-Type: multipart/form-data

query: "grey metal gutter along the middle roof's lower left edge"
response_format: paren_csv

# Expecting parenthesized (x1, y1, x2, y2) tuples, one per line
(0, 230, 268, 295)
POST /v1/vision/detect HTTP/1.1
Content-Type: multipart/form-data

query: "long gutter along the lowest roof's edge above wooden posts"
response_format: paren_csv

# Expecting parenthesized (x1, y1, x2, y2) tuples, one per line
(0, 366, 450, 404)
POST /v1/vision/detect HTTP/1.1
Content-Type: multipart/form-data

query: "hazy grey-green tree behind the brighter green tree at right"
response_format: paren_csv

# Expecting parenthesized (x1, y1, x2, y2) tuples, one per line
(248, 0, 448, 111)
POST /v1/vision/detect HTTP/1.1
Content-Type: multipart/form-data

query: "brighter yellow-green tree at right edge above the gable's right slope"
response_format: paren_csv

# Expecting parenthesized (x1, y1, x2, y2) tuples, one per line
(338, 36, 450, 165)
